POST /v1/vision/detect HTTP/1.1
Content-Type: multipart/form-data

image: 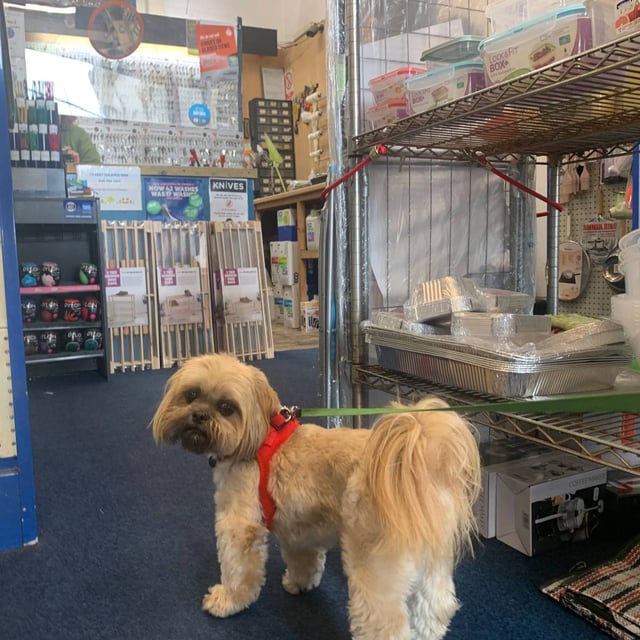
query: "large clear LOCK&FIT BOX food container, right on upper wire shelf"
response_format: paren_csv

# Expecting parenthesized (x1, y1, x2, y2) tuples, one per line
(480, 5, 592, 85)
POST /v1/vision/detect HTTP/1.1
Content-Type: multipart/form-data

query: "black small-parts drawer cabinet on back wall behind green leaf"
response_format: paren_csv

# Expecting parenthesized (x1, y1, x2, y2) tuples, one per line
(249, 98, 296, 197)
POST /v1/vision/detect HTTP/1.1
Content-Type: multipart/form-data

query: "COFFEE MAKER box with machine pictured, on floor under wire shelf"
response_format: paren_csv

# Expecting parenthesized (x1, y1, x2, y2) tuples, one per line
(496, 452, 607, 556)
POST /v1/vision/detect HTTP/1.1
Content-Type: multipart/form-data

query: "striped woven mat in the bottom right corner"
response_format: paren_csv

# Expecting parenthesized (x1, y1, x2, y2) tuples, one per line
(541, 537, 640, 640)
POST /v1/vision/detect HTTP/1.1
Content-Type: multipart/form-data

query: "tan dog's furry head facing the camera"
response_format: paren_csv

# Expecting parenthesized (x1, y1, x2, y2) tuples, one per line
(151, 354, 281, 460)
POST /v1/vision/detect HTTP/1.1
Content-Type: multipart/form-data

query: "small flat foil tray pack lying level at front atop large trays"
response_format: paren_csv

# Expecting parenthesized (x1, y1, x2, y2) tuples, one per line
(451, 311, 551, 342)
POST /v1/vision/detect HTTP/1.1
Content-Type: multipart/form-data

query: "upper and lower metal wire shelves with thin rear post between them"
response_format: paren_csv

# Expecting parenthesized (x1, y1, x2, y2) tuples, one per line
(352, 32, 640, 476)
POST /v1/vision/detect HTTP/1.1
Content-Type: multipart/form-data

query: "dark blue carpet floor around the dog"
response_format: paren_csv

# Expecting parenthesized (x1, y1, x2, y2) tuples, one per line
(0, 350, 623, 640)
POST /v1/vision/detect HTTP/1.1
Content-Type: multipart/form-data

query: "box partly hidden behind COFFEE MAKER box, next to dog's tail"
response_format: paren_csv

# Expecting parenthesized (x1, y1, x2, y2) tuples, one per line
(473, 438, 549, 538)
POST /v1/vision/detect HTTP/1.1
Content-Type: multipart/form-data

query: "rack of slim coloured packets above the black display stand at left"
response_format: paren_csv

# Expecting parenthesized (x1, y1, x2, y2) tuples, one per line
(10, 82, 62, 169)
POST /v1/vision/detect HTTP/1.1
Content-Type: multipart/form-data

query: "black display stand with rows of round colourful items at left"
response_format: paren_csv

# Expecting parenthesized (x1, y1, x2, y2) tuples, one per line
(14, 197, 109, 378)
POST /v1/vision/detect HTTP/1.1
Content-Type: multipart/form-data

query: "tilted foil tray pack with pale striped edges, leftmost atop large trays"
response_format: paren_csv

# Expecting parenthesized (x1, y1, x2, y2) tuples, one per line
(404, 276, 479, 322)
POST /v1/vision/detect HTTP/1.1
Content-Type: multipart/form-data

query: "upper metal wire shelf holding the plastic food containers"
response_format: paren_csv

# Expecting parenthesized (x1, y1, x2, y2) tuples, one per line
(353, 32, 640, 160)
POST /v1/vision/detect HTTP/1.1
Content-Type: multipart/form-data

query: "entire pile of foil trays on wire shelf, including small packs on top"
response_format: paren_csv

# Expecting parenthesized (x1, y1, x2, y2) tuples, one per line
(363, 277, 632, 398)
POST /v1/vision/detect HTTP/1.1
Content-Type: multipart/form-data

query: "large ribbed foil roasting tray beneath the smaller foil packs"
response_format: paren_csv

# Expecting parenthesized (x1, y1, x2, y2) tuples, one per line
(365, 327, 631, 398)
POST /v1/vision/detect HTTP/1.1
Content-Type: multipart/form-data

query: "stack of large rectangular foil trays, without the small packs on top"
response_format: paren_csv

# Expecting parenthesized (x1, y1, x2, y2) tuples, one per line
(363, 321, 633, 398)
